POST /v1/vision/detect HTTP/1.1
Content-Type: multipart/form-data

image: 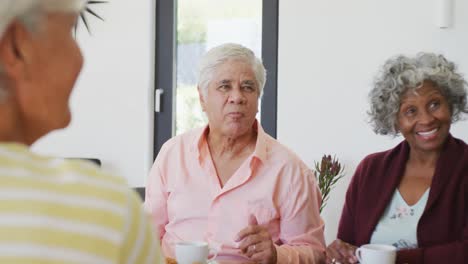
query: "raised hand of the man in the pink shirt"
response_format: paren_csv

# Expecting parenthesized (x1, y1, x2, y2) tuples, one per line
(236, 215, 277, 264)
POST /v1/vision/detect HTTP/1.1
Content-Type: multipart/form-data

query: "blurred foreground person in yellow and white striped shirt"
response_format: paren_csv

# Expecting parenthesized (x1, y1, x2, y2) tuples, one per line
(0, 0, 160, 264)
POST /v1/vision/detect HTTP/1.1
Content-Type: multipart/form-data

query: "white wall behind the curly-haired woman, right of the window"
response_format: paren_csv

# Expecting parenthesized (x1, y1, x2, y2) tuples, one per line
(278, 0, 468, 242)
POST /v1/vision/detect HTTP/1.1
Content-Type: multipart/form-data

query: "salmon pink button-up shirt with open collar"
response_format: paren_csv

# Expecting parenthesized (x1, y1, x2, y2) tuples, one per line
(145, 122, 325, 263)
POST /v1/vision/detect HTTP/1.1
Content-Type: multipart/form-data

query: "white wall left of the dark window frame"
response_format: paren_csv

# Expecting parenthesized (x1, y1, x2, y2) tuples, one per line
(33, 0, 155, 186)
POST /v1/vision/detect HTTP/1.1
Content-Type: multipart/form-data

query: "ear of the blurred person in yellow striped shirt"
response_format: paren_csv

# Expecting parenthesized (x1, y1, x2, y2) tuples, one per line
(0, 21, 31, 80)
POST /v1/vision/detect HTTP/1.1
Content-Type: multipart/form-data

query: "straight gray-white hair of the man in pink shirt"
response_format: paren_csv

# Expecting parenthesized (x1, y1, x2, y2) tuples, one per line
(198, 43, 266, 98)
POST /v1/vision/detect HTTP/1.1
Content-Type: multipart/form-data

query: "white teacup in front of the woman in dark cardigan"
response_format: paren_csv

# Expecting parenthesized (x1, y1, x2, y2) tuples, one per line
(356, 244, 396, 264)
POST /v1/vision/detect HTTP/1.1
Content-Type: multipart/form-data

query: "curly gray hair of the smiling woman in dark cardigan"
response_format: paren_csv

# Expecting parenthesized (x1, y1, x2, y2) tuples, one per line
(367, 53, 468, 136)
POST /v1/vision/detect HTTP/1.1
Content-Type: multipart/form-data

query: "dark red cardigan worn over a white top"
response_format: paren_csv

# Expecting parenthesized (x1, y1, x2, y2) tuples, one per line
(338, 135, 468, 264)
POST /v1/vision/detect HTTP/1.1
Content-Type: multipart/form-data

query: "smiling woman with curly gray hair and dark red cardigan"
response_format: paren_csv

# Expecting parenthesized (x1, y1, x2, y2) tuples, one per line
(327, 53, 468, 264)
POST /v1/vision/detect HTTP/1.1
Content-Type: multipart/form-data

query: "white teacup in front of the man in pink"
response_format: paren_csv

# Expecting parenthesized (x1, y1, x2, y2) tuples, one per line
(175, 241, 217, 264)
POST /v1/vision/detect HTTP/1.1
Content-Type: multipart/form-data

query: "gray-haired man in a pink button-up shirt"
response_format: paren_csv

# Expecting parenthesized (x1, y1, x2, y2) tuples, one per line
(145, 44, 324, 264)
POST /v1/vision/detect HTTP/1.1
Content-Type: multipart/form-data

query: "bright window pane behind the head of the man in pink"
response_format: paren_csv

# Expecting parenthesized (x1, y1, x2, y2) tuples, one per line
(174, 0, 262, 134)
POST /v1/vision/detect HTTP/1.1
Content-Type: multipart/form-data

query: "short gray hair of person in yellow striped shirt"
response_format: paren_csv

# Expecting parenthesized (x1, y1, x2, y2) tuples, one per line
(0, 0, 87, 101)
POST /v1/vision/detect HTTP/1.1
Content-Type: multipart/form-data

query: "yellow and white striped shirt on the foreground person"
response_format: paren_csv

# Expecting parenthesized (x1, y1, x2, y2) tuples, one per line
(0, 143, 160, 264)
